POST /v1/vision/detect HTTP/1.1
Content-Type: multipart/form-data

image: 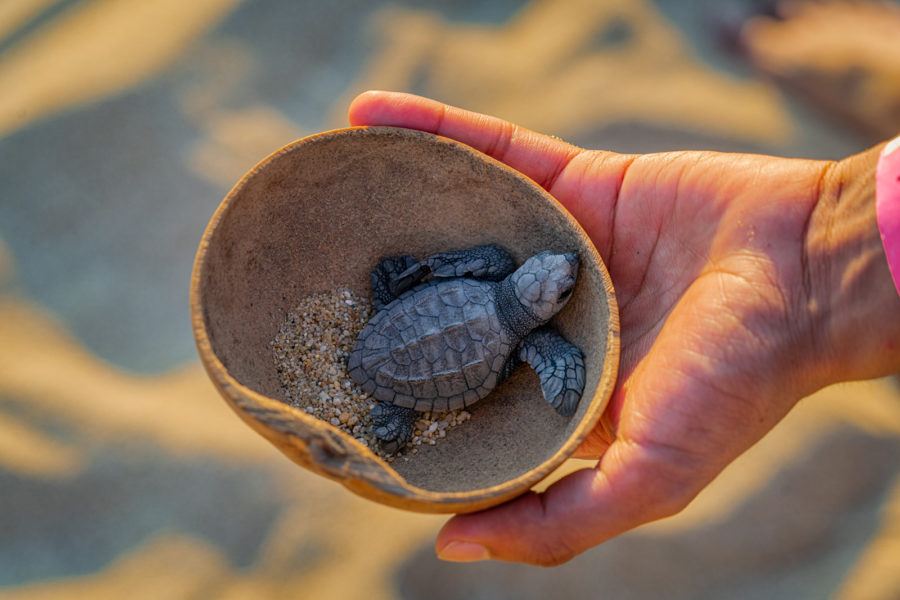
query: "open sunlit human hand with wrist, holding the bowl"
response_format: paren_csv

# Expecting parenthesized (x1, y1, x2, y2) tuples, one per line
(349, 92, 900, 565)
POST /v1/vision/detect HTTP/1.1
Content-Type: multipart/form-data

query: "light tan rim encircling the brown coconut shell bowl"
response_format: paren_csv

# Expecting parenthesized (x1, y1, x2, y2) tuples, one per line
(190, 126, 620, 512)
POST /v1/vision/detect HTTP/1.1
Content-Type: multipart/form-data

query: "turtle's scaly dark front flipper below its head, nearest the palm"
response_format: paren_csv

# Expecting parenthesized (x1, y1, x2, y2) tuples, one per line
(519, 327, 584, 417)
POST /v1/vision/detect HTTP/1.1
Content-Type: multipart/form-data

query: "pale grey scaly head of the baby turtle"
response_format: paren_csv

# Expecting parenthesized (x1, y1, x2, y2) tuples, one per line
(510, 251, 578, 323)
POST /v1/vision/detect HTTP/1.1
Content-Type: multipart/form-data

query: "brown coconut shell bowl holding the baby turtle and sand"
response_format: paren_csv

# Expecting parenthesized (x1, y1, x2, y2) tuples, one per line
(191, 127, 619, 512)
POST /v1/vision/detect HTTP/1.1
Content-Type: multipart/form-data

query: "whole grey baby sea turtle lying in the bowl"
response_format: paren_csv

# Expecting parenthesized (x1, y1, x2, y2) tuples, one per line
(347, 245, 584, 453)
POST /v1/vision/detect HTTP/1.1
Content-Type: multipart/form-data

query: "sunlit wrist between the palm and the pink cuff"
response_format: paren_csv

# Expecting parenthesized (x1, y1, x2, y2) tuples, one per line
(806, 146, 900, 383)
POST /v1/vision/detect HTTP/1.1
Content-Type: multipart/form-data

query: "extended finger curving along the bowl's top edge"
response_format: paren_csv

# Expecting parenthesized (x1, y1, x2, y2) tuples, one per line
(348, 91, 584, 191)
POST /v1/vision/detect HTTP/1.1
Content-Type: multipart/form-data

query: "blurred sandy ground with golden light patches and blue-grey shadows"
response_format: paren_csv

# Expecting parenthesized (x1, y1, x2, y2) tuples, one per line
(0, 0, 900, 600)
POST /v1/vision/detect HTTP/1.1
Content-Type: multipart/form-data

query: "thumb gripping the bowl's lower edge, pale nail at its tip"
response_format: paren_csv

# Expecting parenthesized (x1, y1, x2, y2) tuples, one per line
(435, 441, 699, 566)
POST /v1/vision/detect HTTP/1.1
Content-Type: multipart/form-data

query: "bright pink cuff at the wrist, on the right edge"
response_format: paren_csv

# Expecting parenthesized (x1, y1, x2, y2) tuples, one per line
(875, 137, 900, 293)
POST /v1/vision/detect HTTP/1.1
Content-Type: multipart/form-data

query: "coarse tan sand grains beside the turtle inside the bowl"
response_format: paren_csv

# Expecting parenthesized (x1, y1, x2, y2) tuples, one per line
(270, 287, 471, 462)
